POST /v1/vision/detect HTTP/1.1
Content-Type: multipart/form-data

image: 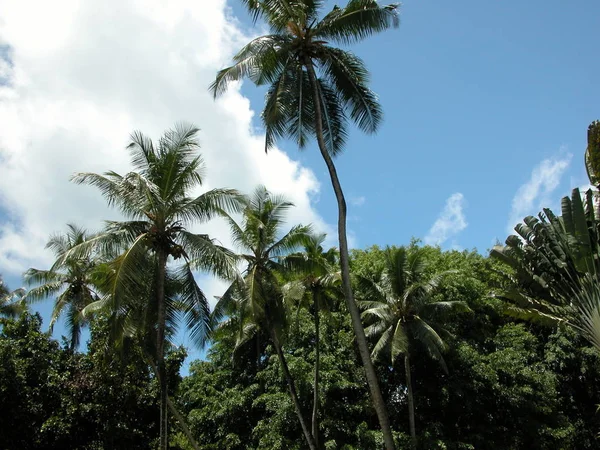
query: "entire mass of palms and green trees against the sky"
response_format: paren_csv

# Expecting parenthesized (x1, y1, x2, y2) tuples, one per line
(0, 0, 600, 444)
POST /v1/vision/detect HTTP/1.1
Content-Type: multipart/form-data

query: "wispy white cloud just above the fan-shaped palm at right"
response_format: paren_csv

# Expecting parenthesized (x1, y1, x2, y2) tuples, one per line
(506, 152, 573, 234)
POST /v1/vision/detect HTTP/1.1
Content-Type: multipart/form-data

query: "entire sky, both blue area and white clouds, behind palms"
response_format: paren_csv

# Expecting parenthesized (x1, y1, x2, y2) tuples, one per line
(0, 0, 600, 362)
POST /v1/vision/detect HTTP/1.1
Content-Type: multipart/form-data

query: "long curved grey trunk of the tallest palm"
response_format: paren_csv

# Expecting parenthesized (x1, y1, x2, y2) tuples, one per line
(305, 58, 395, 450)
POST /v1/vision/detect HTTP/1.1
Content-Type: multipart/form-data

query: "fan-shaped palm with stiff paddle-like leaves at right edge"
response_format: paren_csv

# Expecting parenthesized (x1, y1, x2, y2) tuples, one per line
(491, 189, 600, 349)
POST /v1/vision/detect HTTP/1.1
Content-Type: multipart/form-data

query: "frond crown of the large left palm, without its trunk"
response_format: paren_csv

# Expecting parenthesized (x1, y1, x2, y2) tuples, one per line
(73, 125, 238, 343)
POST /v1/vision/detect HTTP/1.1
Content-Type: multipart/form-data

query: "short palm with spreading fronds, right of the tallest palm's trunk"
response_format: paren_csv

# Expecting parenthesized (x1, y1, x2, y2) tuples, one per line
(357, 247, 468, 445)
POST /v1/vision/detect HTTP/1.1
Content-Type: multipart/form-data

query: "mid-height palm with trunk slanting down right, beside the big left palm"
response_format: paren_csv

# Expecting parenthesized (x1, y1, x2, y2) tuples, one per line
(213, 186, 317, 449)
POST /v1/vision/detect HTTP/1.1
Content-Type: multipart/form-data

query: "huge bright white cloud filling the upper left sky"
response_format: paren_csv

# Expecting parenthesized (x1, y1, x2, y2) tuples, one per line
(0, 0, 334, 306)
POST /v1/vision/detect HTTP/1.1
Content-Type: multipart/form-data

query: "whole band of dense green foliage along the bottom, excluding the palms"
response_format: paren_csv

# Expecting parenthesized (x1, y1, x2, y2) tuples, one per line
(0, 236, 600, 449)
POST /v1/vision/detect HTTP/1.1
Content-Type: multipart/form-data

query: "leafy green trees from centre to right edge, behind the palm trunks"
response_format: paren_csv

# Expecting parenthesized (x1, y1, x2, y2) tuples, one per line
(168, 247, 600, 449)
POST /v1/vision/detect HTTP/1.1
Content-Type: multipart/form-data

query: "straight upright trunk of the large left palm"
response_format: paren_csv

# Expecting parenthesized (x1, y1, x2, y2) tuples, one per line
(156, 250, 169, 450)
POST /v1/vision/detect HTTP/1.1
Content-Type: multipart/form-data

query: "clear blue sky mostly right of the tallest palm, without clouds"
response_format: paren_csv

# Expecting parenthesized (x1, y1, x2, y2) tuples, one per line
(235, 0, 600, 252)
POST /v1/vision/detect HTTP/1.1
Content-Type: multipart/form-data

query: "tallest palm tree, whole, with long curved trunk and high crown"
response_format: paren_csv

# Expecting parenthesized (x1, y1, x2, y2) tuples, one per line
(211, 0, 399, 449)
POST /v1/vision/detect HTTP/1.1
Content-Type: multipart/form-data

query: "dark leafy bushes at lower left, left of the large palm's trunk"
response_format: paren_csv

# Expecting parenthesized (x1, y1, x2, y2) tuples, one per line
(0, 313, 178, 450)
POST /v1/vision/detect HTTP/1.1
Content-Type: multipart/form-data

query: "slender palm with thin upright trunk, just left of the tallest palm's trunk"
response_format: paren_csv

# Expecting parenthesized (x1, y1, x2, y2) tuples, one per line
(284, 234, 341, 448)
